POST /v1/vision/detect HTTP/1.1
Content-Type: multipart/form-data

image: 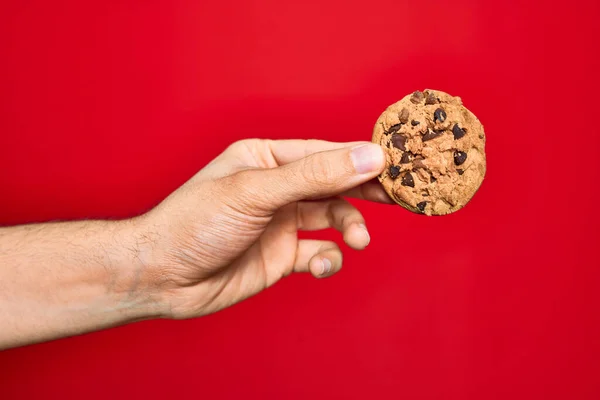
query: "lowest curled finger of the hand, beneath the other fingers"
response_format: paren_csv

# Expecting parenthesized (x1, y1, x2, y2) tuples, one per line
(294, 240, 342, 278)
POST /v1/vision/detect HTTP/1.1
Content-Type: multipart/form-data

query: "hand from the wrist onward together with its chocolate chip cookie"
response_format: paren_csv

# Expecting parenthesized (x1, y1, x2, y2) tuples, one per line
(116, 90, 486, 318)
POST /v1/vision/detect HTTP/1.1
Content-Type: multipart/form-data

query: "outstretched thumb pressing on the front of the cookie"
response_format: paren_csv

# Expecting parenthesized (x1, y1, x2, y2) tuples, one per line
(243, 143, 385, 210)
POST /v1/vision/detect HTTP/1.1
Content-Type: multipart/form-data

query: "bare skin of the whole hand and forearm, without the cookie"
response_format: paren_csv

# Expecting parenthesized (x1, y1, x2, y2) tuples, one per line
(0, 139, 392, 349)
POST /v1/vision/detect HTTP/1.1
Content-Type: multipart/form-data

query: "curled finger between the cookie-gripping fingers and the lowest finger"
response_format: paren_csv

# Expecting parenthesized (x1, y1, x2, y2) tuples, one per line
(298, 198, 371, 250)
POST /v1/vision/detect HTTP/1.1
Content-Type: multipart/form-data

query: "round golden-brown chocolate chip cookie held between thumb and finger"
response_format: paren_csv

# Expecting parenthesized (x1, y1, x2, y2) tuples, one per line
(372, 89, 486, 215)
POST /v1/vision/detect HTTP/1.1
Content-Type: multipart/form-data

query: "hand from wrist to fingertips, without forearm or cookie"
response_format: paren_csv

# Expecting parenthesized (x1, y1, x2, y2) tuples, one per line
(134, 139, 391, 319)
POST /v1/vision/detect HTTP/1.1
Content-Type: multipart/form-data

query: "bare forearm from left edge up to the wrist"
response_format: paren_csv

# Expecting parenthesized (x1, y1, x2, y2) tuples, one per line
(0, 220, 160, 349)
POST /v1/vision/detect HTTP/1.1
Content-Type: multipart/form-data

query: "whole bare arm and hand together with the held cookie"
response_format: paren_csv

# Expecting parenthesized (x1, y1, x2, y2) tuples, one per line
(0, 95, 485, 348)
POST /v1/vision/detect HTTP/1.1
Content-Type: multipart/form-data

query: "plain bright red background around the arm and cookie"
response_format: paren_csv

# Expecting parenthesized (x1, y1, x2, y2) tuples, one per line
(0, 0, 600, 399)
